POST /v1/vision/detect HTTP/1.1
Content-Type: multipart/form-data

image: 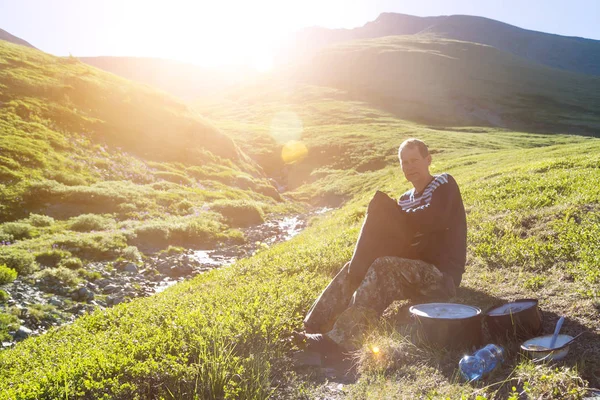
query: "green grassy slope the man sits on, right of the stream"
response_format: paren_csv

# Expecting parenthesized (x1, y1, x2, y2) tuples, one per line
(0, 99, 600, 399)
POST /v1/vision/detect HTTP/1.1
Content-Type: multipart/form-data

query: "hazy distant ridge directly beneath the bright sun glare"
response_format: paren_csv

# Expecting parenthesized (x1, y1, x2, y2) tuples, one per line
(79, 57, 252, 100)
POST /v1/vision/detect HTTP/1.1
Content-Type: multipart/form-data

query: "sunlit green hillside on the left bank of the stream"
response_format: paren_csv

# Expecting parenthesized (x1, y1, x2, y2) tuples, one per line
(0, 41, 290, 330)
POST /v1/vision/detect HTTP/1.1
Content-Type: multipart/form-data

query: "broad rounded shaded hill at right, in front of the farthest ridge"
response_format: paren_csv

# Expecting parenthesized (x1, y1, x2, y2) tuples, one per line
(296, 36, 600, 134)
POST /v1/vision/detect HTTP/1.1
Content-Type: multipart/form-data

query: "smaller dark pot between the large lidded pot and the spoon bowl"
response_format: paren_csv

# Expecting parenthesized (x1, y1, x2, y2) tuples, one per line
(485, 299, 543, 340)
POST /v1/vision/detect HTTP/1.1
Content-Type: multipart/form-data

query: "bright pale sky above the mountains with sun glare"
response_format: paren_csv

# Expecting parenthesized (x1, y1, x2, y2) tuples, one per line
(0, 0, 600, 69)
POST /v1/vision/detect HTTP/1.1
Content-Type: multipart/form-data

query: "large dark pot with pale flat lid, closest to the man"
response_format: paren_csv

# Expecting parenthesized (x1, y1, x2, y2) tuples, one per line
(409, 303, 482, 349)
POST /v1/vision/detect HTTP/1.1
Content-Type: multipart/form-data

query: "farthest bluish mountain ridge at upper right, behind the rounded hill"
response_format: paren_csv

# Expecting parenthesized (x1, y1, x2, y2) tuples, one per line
(281, 13, 600, 75)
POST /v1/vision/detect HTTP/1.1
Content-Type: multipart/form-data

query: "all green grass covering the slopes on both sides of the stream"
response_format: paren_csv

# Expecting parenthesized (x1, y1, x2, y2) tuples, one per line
(0, 35, 600, 399)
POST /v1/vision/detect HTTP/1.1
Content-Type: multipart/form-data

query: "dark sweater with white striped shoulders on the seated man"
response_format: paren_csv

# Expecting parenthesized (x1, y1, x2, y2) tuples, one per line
(398, 173, 467, 286)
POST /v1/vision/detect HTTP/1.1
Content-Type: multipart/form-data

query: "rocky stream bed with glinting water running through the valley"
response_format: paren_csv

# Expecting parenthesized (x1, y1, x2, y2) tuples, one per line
(0, 208, 329, 350)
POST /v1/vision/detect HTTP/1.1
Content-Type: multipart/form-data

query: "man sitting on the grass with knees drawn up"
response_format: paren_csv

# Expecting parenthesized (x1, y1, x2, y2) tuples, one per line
(297, 139, 467, 352)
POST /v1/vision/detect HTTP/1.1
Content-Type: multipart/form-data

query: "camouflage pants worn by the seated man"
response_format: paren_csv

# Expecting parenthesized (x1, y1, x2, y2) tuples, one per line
(305, 256, 455, 350)
